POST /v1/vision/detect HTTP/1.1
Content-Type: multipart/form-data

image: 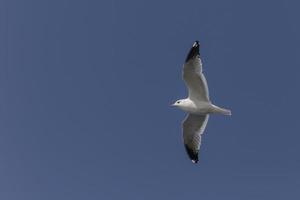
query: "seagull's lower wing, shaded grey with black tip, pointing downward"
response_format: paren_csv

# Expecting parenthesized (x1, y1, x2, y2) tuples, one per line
(182, 114, 209, 163)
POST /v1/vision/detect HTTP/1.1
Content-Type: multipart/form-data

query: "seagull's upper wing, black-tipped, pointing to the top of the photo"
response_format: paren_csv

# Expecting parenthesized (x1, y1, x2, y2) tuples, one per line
(183, 41, 209, 102)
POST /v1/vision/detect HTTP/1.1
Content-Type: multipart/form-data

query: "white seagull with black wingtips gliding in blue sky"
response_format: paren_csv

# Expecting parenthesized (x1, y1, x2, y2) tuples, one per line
(172, 41, 231, 163)
